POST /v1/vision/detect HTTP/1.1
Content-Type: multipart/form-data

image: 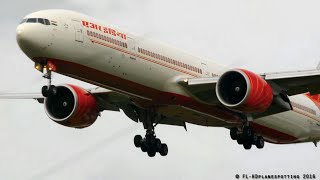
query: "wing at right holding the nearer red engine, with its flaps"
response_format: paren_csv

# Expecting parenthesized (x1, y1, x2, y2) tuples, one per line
(178, 65, 320, 118)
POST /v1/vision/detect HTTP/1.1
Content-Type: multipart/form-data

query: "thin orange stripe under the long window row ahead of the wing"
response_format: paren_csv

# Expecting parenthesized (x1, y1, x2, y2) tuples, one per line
(89, 38, 200, 77)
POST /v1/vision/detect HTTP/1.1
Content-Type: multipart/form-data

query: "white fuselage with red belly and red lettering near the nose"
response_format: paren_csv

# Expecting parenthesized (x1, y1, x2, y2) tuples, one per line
(17, 10, 320, 143)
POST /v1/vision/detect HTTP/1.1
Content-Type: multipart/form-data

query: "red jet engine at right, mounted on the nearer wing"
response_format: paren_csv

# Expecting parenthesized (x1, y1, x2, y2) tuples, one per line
(216, 69, 273, 113)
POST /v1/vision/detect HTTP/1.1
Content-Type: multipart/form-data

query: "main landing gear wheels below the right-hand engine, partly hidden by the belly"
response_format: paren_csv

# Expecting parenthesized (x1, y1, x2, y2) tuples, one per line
(230, 125, 264, 150)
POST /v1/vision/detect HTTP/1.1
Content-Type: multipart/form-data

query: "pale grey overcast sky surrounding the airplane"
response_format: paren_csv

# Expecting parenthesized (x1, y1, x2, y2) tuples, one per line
(0, 0, 320, 180)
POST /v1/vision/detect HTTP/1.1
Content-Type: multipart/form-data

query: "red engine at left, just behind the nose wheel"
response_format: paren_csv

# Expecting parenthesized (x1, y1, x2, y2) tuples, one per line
(44, 85, 99, 128)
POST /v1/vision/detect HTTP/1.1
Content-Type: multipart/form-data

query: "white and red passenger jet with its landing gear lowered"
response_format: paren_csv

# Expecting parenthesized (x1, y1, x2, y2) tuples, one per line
(0, 9, 320, 157)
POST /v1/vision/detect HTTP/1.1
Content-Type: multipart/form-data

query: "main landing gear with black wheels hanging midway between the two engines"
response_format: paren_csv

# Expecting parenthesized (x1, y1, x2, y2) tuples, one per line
(134, 110, 168, 157)
